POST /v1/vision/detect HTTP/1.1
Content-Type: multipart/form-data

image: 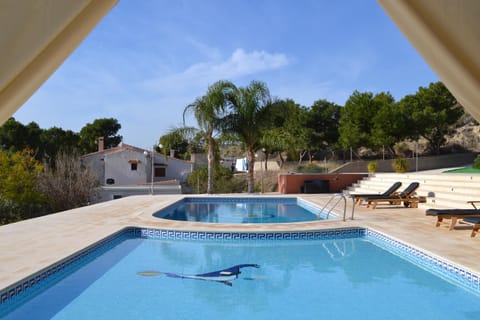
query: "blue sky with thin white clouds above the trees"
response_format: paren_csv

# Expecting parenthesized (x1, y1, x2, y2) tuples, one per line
(14, 0, 438, 147)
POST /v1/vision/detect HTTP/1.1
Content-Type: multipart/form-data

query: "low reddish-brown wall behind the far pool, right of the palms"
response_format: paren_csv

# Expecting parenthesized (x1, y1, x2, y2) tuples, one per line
(278, 173, 368, 193)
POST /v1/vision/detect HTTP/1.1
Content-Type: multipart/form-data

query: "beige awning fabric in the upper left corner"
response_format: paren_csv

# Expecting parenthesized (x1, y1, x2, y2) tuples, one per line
(0, 0, 118, 125)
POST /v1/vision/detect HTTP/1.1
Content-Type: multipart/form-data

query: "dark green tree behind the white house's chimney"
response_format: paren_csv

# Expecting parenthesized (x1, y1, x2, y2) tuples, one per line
(79, 118, 123, 153)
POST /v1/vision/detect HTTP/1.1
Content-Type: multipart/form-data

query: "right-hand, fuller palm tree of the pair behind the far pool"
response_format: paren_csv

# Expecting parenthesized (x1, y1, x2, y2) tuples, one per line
(222, 81, 271, 193)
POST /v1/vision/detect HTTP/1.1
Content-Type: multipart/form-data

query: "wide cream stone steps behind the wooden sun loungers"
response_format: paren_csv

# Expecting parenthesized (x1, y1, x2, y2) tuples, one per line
(344, 171, 480, 208)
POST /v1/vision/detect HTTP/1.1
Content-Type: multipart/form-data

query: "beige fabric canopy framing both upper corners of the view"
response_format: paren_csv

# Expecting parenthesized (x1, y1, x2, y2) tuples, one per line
(0, 0, 480, 124)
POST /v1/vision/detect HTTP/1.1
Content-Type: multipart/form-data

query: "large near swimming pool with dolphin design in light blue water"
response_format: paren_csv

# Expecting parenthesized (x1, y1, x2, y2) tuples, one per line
(0, 228, 480, 319)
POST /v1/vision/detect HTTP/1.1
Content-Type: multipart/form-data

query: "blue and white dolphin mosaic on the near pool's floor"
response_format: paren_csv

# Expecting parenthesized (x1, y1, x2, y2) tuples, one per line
(137, 264, 260, 286)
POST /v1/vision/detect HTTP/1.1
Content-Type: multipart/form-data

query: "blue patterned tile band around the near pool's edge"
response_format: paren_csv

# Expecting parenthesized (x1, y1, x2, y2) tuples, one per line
(0, 227, 480, 305)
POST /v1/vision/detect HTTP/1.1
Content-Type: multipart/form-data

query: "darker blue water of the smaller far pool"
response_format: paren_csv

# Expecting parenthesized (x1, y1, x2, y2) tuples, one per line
(154, 198, 326, 223)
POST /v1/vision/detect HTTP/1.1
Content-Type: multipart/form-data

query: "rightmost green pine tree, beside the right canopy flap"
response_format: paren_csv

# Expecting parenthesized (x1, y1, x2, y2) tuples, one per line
(399, 82, 464, 154)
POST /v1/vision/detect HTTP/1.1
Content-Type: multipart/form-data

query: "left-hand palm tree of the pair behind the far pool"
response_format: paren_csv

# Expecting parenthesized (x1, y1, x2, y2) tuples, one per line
(183, 80, 236, 193)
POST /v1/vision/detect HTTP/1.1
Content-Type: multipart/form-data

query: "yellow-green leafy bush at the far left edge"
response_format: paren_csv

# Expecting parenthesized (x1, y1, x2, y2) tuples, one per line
(0, 149, 45, 224)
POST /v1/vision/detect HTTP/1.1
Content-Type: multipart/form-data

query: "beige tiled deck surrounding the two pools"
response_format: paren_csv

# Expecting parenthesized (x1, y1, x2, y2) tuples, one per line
(0, 194, 480, 290)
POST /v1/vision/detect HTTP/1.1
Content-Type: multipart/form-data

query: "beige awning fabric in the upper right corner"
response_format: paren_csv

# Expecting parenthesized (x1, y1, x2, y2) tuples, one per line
(377, 0, 480, 121)
